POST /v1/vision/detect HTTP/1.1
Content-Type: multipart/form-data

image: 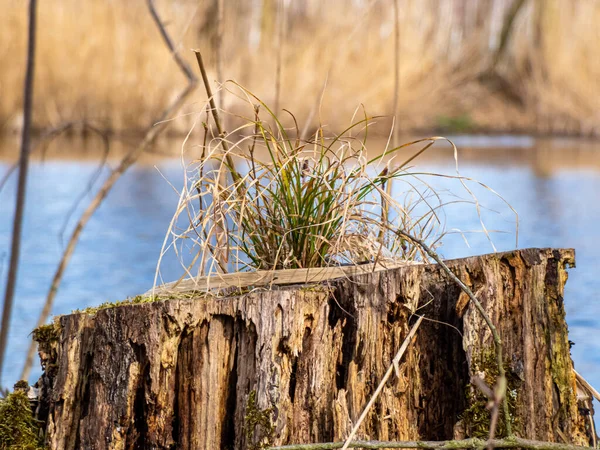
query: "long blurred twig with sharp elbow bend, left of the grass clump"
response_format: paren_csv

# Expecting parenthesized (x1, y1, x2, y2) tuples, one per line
(21, 0, 197, 379)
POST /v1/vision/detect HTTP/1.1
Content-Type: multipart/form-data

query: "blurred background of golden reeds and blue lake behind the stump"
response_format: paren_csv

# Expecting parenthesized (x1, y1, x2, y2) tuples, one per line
(0, 0, 600, 418)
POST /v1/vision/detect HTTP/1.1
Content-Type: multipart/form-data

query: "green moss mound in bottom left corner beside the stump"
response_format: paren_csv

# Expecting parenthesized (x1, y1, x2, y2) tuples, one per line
(0, 390, 45, 450)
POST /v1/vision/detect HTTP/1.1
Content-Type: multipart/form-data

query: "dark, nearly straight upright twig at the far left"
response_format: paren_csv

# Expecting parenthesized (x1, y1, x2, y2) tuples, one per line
(0, 0, 37, 379)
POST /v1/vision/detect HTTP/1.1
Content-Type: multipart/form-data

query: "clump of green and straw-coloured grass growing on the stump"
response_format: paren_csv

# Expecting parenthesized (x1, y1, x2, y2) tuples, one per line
(159, 82, 516, 277)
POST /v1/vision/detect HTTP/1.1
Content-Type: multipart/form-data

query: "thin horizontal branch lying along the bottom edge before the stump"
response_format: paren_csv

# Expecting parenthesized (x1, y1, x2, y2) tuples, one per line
(268, 437, 592, 450)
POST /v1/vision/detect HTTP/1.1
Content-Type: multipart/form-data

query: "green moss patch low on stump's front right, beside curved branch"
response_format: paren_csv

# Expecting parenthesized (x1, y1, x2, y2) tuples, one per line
(460, 349, 520, 439)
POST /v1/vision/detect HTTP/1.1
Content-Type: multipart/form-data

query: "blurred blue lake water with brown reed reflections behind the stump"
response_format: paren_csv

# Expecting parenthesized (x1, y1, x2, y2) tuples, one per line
(0, 136, 600, 412)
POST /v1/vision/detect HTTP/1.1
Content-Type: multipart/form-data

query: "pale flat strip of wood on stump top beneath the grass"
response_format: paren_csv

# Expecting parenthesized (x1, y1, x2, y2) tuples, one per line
(144, 261, 421, 296)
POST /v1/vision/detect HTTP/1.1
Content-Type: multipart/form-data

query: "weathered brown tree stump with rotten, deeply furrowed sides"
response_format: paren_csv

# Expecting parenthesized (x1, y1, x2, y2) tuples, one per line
(34, 249, 590, 449)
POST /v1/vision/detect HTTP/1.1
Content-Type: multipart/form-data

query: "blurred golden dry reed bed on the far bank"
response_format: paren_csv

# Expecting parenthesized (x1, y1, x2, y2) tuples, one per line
(0, 0, 600, 135)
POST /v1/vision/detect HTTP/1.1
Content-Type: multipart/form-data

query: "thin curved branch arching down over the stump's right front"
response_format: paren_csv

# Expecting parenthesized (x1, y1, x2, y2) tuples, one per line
(396, 230, 512, 436)
